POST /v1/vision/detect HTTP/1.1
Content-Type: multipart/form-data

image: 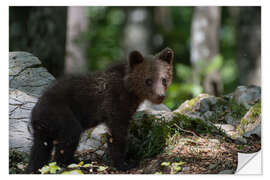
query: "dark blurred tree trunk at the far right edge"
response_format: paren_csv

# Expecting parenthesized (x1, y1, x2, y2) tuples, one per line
(237, 7, 261, 85)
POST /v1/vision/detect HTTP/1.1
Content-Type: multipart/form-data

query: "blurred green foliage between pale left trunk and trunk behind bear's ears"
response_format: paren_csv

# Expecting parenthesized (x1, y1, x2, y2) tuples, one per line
(84, 6, 125, 71)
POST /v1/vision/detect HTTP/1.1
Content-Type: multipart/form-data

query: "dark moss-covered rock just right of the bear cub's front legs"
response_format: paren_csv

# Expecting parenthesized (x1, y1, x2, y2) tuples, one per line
(128, 111, 223, 160)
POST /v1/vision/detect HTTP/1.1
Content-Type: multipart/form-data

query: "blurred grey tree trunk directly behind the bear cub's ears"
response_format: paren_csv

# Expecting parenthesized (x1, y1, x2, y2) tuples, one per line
(123, 7, 152, 56)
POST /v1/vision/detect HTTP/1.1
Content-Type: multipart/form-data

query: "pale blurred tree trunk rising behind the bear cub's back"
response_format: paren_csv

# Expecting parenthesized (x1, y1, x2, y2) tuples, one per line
(65, 7, 88, 74)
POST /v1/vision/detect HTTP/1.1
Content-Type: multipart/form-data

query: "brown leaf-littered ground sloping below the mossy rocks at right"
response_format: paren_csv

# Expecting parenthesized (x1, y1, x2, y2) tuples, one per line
(77, 134, 261, 174)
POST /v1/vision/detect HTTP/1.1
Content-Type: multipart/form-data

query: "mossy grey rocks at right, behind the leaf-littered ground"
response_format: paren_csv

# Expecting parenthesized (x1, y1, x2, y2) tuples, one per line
(174, 86, 261, 143)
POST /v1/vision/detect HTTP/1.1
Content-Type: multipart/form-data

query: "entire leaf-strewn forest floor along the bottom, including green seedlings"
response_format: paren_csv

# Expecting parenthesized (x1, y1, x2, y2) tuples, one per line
(10, 132, 261, 174)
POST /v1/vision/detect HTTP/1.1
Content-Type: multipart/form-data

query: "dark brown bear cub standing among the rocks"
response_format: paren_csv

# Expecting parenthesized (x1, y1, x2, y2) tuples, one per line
(28, 48, 174, 173)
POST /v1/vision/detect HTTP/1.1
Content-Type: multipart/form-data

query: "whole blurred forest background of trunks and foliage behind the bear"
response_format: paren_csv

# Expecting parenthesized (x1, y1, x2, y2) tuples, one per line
(9, 7, 261, 109)
